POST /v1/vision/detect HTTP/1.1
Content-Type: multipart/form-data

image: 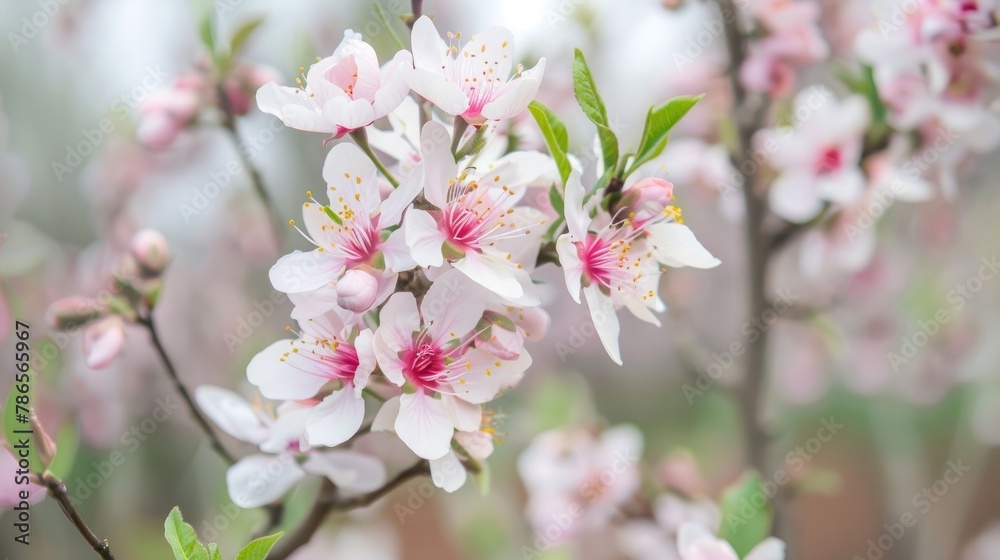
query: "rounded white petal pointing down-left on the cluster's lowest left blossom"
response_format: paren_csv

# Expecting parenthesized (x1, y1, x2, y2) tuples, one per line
(226, 454, 305, 508)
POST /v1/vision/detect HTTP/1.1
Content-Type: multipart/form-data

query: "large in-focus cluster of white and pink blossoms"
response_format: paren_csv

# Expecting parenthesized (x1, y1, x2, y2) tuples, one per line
(198, 17, 719, 500)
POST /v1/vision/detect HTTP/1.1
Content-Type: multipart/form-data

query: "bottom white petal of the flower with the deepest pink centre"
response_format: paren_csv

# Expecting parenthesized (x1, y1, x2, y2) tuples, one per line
(396, 393, 455, 459)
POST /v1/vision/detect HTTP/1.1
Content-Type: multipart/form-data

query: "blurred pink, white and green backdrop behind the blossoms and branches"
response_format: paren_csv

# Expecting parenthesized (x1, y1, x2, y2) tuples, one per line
(0, 0, 1000, 560)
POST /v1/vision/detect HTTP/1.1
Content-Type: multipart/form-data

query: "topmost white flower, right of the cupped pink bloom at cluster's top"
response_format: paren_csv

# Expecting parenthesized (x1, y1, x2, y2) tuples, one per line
(409, 16, 545, 126)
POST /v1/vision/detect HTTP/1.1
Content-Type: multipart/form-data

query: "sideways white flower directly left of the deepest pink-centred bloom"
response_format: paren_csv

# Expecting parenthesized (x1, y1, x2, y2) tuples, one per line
(247, 313, 375, 447)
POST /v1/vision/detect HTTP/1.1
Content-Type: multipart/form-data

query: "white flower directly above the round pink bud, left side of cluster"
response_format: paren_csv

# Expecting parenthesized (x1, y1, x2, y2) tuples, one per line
(270, 143, 423, 317)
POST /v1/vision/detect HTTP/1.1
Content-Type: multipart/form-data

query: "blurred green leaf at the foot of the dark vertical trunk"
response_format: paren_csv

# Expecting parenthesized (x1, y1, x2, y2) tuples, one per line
(719, 473, 774, 558)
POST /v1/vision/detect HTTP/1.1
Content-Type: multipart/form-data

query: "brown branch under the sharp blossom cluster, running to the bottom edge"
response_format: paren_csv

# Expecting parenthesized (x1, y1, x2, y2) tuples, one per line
(267, 461, 430, 560)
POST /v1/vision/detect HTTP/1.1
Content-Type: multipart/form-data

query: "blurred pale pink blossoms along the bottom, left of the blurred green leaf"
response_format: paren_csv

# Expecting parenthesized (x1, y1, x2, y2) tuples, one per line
(518, 425, 785, 560)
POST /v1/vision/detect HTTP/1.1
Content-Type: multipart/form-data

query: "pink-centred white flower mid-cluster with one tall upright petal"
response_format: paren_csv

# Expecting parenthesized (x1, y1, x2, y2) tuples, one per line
(403, 122, 546, 306)
